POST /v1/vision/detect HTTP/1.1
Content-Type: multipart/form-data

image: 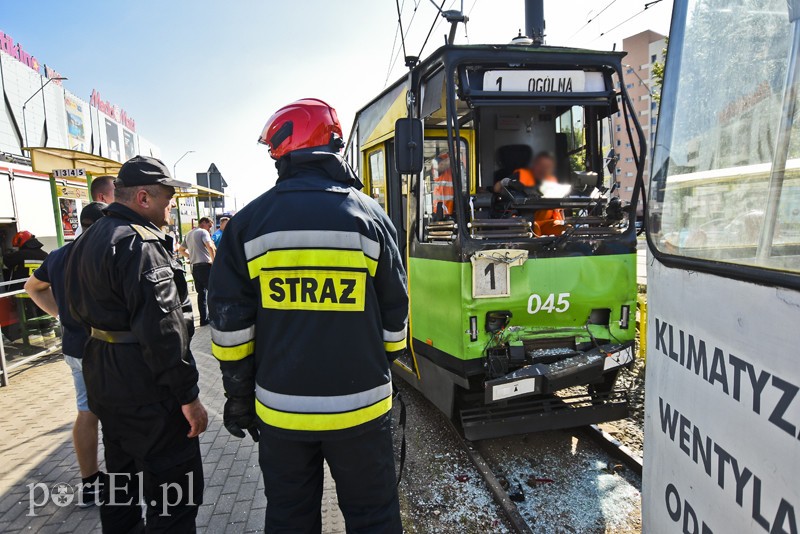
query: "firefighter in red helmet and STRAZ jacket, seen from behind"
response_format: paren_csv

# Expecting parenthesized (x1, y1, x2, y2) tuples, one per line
(209, 99, 408, 533)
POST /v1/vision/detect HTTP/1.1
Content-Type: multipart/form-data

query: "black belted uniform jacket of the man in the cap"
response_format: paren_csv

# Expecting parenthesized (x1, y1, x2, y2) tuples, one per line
(65, 203, 199, 408)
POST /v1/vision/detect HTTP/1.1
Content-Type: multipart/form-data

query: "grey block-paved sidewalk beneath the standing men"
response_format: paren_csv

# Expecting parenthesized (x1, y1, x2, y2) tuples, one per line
(0, 327, 345, 534)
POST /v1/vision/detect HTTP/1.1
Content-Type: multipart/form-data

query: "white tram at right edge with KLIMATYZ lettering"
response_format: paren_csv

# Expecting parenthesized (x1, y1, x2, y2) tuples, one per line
(642, 0, 800, 533)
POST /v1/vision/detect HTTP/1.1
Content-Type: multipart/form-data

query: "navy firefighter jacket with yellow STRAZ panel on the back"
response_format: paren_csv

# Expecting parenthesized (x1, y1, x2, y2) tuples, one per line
(209, 151, 408, 440)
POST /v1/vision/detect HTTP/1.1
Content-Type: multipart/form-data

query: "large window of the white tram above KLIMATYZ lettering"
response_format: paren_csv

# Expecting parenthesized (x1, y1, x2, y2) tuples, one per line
(649, 0, 800, 273)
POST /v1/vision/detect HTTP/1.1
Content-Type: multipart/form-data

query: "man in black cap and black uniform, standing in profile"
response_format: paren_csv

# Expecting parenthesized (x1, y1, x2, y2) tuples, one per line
(66, 156, 208, 533)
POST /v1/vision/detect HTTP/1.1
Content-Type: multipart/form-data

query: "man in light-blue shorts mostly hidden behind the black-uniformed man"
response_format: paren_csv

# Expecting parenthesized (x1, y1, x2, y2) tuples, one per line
(25, 202, 108, 506)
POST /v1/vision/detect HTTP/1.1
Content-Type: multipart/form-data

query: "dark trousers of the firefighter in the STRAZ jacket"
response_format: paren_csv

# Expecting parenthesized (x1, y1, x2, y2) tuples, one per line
(258, 417, 403, 534)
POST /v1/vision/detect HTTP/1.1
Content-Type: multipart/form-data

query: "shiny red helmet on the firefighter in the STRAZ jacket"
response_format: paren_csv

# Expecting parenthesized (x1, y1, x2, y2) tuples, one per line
(258, 98, 344, 159)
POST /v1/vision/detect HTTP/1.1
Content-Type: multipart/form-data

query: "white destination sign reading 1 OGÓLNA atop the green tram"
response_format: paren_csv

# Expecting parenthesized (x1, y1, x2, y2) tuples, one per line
(483, 70, 605, 94)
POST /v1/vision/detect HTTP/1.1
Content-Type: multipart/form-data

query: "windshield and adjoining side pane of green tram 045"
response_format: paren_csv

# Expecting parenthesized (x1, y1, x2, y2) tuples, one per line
(422, 103, 628, 239)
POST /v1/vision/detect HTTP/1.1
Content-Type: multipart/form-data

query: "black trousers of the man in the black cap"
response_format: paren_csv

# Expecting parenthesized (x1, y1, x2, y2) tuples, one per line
(93, 400, 204, 534)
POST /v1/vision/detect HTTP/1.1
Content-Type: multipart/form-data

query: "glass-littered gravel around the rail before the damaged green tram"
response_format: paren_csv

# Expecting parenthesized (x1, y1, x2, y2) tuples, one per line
(395, 381, 641, 534)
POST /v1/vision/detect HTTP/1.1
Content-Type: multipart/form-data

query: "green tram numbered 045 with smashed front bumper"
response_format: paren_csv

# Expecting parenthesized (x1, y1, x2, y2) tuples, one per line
(346, 44, 645, 439)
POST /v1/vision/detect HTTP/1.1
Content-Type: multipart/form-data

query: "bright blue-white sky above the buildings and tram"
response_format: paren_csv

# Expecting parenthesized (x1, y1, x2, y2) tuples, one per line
(0, 0, 672, 208)
